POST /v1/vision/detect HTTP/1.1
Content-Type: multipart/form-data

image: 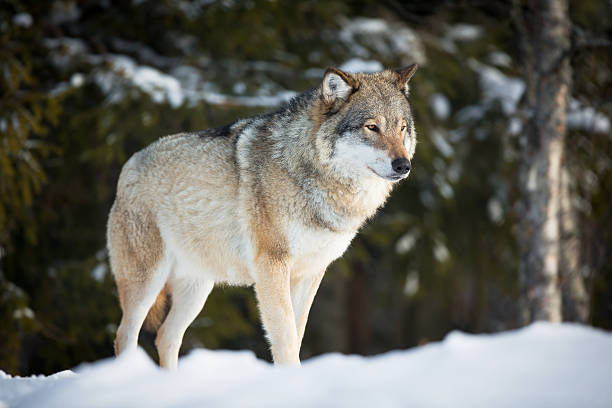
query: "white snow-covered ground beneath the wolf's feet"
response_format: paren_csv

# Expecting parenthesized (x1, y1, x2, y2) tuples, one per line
(0, 323, 612, 408)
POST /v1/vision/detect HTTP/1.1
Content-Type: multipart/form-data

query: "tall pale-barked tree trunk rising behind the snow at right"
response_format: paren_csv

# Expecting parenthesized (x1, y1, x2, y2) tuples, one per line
(515, 0, 571, 323)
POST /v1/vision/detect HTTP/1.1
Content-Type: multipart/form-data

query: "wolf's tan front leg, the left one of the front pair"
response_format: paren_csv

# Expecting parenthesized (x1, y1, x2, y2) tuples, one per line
(255, 256, 300, 365)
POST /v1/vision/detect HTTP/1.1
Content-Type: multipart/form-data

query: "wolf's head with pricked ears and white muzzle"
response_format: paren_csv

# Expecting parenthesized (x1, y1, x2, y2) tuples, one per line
(318, 64, 417, 181)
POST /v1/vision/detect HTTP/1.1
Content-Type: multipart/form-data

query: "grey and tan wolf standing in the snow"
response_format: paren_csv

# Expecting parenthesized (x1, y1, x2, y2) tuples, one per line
(107, 64, 417, 369)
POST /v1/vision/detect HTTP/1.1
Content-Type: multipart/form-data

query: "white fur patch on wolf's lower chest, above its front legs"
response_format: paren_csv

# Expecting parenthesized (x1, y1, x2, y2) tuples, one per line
(287, 221, 355, 275)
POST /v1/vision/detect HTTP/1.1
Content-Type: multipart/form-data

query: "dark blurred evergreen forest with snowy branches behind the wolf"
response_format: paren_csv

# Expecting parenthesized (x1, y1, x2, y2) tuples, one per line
(0, 0, 612, 375)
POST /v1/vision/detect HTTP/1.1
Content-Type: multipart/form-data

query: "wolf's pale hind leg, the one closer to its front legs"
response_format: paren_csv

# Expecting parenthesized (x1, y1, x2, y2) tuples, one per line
(155, 278, 214, 370)
